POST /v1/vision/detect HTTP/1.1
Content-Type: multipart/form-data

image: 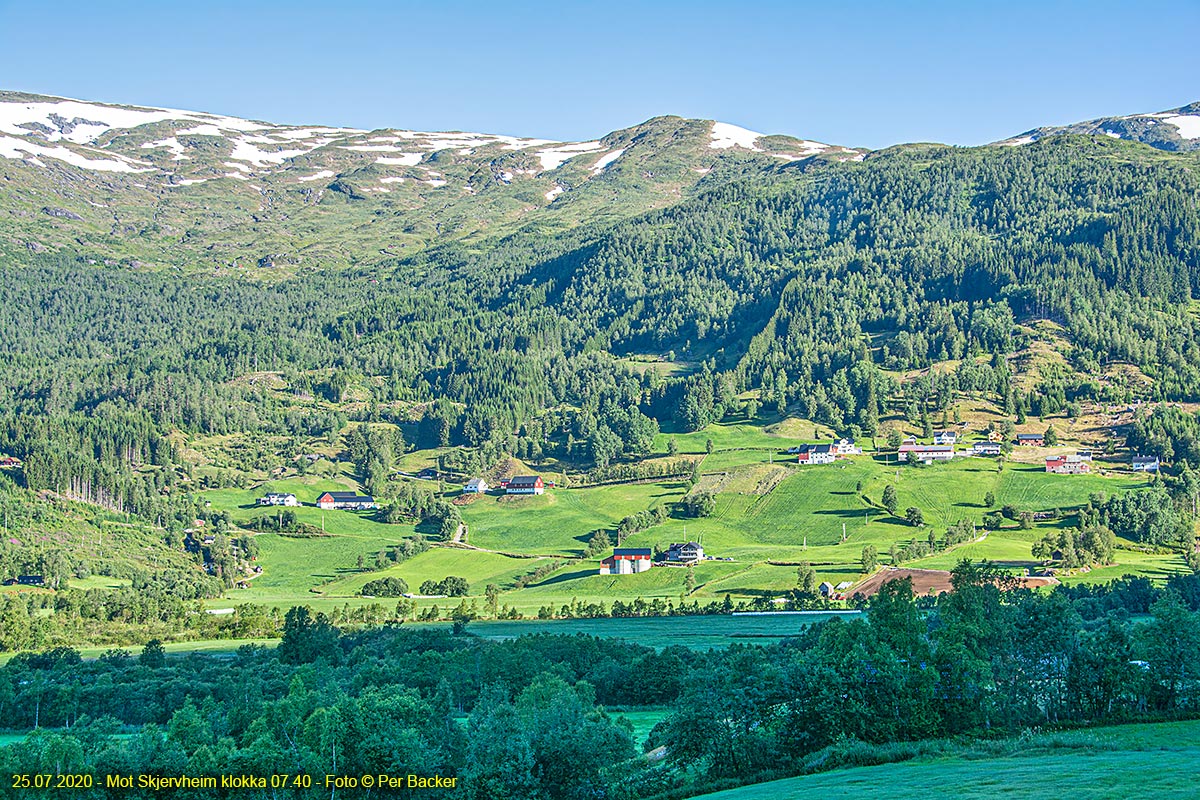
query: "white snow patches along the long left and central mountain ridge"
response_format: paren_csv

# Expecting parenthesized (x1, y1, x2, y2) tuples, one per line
(0, 92, 860, 181)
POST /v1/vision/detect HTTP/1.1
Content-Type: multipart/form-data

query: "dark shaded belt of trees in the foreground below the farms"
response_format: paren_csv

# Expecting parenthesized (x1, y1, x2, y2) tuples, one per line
(7, 564, 1200, 800)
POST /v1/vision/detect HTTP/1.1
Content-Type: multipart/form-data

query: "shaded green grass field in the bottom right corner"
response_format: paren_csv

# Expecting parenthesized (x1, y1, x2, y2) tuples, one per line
(702, 722, 1200, 800)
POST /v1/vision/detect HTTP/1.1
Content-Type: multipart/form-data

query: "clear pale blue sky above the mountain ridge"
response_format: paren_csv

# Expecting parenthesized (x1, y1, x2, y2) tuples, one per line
(0, 0, 1200, 148)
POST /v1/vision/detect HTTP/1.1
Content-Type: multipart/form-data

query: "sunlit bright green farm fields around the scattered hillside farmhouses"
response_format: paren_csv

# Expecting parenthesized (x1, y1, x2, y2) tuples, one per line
(189, 420, 1183, 615)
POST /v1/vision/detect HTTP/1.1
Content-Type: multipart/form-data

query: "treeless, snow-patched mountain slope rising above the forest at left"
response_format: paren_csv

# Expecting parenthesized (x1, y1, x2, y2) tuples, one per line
(0, 92, 863, 271)
